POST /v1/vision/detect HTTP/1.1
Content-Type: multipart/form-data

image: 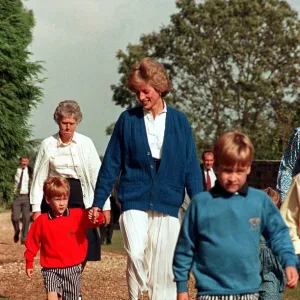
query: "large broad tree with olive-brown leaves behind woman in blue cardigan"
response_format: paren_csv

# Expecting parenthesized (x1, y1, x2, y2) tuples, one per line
(112, 0, 300, 159)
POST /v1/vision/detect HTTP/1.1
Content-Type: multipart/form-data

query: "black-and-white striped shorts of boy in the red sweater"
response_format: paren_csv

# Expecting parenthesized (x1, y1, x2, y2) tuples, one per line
(42, 264, 81, 300)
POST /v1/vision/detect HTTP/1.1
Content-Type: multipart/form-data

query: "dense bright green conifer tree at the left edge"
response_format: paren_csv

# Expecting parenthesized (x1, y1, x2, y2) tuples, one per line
(0, 0, 42, 204)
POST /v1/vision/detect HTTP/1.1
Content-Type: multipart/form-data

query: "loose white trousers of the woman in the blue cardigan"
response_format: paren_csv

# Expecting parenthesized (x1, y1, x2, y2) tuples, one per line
(120, 210, 180, 300)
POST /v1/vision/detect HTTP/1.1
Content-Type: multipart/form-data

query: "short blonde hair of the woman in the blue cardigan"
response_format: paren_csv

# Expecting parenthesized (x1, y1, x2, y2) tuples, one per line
(127, 57, 172, 97)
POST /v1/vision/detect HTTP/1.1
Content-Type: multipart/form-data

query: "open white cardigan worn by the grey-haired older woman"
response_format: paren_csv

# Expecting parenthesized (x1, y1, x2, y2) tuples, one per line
(30, 132, 110, 212)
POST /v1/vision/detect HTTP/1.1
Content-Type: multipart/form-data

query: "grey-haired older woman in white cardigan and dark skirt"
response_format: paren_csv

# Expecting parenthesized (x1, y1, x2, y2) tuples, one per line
(30, 100, 110, 284)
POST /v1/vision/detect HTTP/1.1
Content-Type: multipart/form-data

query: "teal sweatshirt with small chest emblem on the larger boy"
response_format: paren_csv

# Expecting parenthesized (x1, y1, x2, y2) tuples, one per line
(173, 182, 298, 295)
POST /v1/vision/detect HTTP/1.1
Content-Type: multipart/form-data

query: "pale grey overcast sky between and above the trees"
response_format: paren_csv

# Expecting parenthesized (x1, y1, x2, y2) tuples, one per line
(23, 0, 300, 155)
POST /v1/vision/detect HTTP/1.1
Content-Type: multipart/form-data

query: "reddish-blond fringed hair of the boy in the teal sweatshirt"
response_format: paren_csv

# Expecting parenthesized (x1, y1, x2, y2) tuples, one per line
(213, 131, 254, 167)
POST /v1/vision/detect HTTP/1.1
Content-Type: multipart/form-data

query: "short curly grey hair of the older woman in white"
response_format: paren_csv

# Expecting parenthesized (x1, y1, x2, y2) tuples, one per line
(53, 100, 82, 124)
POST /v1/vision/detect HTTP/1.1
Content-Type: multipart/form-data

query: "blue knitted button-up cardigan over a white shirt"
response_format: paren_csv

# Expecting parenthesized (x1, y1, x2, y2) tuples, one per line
(93, 106, 203, 217)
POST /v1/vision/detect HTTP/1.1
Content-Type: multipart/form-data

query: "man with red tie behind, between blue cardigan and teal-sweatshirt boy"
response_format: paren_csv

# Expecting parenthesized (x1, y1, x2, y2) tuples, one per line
(200, 151, 217, 191)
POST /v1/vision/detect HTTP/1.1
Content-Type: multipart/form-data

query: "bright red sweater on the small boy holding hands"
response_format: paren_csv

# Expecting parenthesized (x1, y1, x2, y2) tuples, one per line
(24, 208, 104, 269)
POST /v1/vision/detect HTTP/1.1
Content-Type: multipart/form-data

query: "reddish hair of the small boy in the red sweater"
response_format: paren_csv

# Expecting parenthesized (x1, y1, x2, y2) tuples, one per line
(43, 177, 70, 201)
